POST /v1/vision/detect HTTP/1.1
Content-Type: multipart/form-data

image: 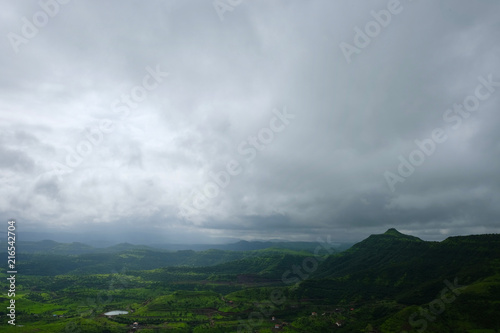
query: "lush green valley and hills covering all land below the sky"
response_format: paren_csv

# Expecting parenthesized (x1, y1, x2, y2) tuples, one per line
(0, 229, 500, 333)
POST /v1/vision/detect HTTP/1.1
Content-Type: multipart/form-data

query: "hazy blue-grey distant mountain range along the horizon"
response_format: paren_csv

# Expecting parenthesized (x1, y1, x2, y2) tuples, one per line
(0, 240, 349, 275)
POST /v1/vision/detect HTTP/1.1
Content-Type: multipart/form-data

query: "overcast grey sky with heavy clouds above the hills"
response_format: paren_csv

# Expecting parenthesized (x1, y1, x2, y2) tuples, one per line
(0, 0, 500, 244)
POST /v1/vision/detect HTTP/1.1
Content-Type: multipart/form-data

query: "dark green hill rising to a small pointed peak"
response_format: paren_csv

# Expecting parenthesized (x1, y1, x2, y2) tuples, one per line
(313, 229, 500, 291)
